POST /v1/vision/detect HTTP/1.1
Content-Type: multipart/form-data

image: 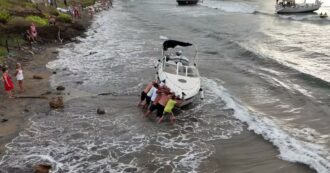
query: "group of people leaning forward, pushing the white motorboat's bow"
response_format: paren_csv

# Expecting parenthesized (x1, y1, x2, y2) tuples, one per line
(138, 81, 183, 124)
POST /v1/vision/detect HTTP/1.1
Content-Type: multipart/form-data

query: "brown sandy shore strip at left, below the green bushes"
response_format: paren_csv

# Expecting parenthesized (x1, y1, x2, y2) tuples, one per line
(0, 8, 98, 158)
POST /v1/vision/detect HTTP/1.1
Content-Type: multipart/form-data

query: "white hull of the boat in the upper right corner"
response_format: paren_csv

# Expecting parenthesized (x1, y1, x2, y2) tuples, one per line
(276, 4, 321, 13)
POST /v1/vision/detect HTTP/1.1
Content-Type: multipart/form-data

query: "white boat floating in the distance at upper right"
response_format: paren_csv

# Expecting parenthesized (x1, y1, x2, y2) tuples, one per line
(276, 0, 322, 13)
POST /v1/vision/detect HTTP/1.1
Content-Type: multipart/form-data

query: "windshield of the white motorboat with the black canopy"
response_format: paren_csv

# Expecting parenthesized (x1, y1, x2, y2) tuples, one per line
(164, 63, 199, 77)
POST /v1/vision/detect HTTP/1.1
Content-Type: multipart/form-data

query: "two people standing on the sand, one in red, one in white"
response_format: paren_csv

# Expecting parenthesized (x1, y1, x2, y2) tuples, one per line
(1, 63, 24, 98)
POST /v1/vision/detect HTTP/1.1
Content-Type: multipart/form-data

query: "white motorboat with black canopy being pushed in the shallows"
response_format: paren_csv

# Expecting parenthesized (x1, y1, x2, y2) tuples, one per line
(157, 40, 204, 107)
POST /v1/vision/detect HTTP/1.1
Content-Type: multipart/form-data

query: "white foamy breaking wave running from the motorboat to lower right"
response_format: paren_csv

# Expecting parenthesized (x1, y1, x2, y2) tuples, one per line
(203, 78, 330, 173)
